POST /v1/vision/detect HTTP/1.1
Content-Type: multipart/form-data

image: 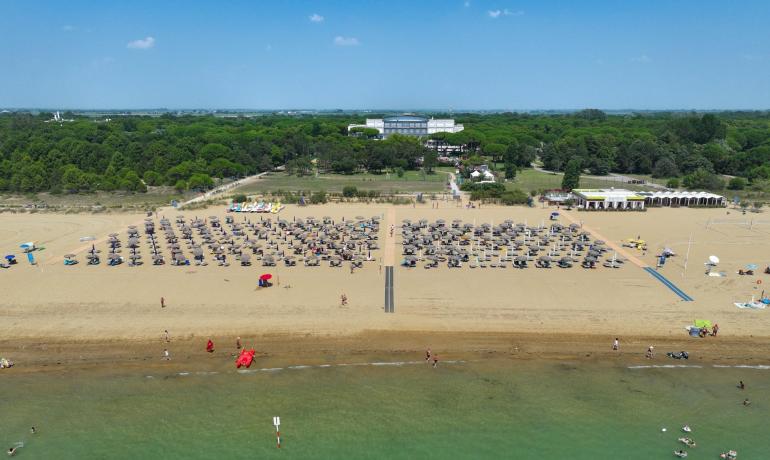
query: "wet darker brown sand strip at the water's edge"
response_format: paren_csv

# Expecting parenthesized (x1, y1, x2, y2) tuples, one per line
(0, 330, 770, 376)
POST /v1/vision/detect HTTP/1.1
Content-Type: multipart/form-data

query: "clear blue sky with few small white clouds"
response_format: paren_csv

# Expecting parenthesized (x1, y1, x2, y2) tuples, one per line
(0, 0, 770, 110)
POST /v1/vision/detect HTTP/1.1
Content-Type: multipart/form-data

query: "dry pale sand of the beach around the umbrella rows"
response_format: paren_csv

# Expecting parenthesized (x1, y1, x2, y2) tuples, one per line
(0, 202, 770, 356)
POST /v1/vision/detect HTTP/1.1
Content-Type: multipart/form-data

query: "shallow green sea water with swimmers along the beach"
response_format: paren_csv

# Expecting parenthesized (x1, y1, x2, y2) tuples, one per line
(0, 360, 770, 460)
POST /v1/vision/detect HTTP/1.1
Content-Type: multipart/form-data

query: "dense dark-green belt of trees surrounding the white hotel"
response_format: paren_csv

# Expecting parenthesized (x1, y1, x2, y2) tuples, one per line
(0, 110, 770, 193)
